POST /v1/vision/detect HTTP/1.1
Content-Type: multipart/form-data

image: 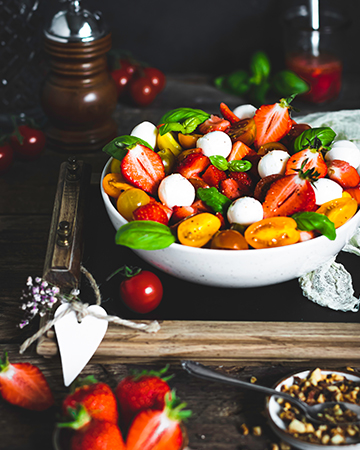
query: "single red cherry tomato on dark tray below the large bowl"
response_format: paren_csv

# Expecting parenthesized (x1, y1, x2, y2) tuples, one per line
(120, 270, 163, 314)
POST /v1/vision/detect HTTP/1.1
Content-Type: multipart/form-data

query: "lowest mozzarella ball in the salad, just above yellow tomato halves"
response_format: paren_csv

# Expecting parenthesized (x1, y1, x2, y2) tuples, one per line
(227, 197, 264, 226)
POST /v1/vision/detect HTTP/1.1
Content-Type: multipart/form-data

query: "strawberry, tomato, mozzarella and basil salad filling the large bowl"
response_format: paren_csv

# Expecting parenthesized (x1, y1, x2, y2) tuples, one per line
(102, 96, 360, 250)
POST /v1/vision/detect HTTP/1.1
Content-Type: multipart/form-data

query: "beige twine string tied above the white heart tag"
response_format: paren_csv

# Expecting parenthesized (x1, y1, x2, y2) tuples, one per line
(19, 266, 160, 354)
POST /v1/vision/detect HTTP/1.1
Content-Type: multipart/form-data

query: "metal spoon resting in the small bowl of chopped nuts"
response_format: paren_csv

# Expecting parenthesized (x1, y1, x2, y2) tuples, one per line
(181, 361, 360, 426)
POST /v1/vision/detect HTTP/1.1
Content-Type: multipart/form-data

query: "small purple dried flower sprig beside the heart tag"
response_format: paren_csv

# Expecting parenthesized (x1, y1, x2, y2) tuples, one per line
(19, 277, 79, 329)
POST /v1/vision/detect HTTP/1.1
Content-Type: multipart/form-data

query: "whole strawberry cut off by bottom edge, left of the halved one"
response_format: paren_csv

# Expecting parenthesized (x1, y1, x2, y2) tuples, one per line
(57, 404, 126, 450)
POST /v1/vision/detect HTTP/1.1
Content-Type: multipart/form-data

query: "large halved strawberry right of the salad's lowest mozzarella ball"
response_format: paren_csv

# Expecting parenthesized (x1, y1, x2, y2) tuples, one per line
(263, 169, 315, 219)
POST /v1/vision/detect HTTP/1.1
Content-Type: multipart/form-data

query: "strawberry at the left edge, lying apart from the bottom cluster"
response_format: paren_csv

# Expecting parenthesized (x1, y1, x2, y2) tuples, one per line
(0, 352, 54, 411)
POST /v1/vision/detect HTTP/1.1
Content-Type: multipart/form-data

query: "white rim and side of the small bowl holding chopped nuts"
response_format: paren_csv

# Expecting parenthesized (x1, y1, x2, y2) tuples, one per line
(266, 370, 360, 450)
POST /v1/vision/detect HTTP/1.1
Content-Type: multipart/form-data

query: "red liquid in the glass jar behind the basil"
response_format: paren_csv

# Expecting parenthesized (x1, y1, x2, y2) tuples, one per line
(286, 54, 342, 103)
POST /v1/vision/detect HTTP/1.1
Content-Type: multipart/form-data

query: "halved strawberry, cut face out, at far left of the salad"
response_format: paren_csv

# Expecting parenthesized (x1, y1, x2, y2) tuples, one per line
(120, 144, 165, 196)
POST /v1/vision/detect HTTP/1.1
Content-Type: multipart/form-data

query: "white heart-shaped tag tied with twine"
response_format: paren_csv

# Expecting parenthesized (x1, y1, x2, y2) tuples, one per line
(54, 303, 108, 386)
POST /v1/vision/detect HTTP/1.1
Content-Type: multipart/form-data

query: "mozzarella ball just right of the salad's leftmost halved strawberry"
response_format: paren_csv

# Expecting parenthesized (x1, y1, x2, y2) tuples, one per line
(158, 173, 195, 208)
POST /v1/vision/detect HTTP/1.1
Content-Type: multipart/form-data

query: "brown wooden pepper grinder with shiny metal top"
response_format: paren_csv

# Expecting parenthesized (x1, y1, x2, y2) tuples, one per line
(41, 0, 117, 153)
